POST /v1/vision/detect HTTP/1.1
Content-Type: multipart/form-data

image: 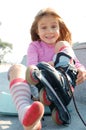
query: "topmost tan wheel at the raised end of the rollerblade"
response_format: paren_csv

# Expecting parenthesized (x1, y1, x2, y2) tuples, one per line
(26, 65, 39, 85)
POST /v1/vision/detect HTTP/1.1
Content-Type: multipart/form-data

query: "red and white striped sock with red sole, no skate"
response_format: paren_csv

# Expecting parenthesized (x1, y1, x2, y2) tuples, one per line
(10, 78, 44, 127)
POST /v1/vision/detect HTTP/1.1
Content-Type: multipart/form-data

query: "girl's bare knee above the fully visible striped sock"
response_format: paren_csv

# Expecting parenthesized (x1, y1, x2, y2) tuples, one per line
(8, 64, 26, 81)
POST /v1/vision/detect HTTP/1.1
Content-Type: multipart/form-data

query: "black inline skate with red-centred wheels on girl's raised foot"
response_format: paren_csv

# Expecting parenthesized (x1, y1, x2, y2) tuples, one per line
(26, 52, 77, 125)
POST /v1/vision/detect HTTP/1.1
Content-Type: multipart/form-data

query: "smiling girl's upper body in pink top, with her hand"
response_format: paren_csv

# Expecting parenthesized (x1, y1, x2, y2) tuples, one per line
(27, 8, 86, 85)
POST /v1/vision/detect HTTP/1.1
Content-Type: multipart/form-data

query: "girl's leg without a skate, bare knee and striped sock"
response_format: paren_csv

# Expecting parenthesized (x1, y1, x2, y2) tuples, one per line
(8, 64, 44, 130)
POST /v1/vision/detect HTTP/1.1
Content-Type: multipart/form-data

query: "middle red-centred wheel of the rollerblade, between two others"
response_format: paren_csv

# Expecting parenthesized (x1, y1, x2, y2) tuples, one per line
(39, 88, 51, 106)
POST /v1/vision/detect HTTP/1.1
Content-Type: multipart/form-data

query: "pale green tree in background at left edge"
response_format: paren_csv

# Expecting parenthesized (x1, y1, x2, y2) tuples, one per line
(0, 39, 13, 63)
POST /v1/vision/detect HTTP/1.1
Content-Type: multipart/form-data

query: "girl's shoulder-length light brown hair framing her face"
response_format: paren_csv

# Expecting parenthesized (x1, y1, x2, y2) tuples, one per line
(30, 8, 72, 44)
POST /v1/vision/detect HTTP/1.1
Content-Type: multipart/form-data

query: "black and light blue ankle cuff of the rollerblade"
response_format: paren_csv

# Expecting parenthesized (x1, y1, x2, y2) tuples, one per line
(54, 52, 77, 87)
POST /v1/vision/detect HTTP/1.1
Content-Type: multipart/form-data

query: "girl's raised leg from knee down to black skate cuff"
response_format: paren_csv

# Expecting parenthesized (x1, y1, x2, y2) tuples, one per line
(54, 41, 79, 87)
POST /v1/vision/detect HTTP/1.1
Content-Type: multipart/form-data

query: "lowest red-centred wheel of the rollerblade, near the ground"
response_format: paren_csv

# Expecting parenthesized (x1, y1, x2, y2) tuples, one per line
(52, 108, 63, 125)
